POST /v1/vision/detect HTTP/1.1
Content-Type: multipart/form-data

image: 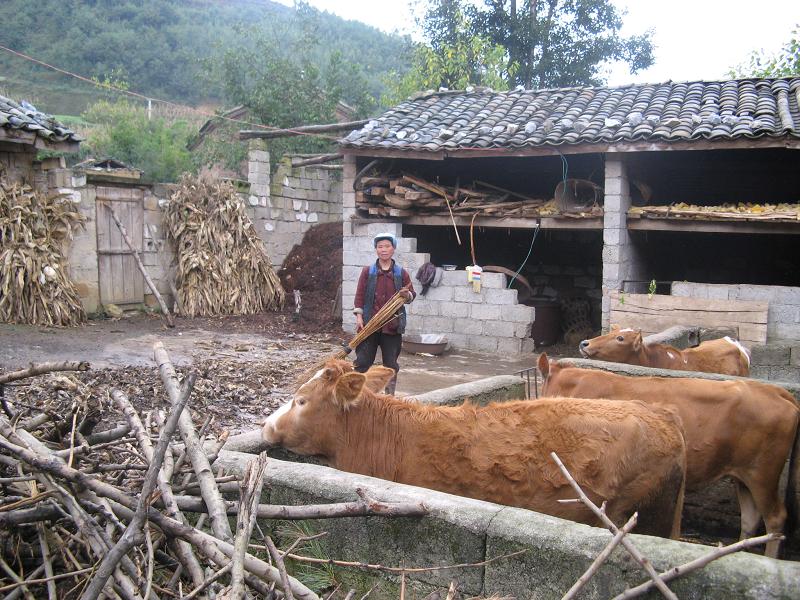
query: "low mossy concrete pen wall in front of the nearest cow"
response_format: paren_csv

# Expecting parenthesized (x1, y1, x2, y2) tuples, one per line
(216, 450, 800, 600)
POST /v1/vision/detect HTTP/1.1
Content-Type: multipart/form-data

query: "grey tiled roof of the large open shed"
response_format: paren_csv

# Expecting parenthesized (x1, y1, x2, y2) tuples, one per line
(340, 78, 800, 153)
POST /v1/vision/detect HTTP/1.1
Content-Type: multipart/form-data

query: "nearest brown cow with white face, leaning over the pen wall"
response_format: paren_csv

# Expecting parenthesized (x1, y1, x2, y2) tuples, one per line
(263, 360, 686, 537)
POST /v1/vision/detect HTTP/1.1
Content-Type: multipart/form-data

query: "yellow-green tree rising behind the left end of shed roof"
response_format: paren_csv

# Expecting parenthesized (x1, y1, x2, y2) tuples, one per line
(383, 0, 516, 105)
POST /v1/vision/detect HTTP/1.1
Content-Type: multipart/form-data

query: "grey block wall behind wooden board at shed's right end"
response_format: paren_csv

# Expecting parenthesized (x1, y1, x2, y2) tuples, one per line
(672, 281, 800, 383)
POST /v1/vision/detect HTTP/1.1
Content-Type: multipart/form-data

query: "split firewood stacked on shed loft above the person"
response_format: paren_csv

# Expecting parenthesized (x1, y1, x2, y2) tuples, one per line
(356, 173, 588, 218)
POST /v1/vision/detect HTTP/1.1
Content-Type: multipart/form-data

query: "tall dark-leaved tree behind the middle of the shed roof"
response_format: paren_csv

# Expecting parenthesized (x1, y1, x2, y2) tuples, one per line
(423, 0, 653, 88)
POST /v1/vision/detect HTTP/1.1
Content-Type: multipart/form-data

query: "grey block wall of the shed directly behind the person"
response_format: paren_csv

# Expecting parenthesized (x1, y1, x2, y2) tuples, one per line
(342, 156, 535, 354)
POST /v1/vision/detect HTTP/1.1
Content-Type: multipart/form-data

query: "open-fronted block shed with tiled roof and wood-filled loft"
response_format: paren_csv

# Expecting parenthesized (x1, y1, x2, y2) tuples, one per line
(340, 78, 800, 352)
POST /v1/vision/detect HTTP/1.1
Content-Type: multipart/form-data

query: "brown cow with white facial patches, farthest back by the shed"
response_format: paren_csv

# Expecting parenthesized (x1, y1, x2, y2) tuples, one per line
(578, 328, 750, 377)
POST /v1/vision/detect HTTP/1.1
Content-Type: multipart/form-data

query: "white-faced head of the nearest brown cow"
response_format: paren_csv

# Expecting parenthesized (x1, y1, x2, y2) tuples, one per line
(261, 360, 394, 457)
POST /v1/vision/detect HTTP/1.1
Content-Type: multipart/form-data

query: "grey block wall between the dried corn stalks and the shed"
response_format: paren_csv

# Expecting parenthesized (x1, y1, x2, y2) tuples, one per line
(246, 144, 342, 267)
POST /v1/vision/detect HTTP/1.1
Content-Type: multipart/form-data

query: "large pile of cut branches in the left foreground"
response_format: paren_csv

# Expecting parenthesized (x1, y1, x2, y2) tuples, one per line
(0, 350, 425, 600)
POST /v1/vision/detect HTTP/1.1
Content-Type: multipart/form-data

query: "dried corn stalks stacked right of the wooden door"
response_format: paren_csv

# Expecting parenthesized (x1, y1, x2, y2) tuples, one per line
(164, 175, 285, 317)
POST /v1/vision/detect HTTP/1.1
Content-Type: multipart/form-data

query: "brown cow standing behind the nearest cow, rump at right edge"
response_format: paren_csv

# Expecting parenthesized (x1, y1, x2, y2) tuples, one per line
(538, 353, 800, 557)
